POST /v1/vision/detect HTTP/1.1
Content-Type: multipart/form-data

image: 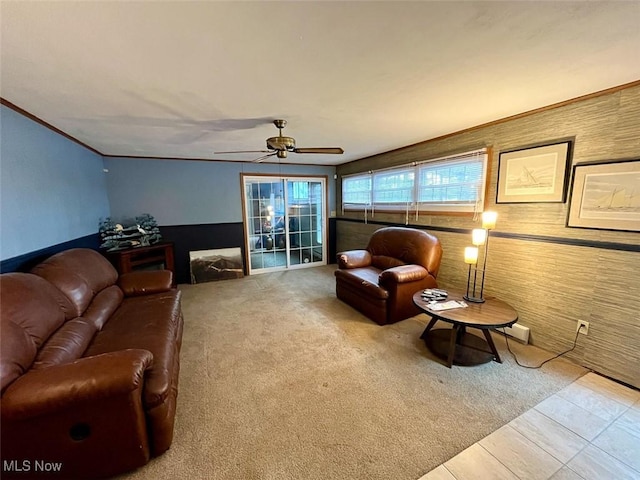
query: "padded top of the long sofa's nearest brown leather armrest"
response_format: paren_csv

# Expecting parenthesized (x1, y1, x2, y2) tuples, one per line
(2, 349, 153, 421)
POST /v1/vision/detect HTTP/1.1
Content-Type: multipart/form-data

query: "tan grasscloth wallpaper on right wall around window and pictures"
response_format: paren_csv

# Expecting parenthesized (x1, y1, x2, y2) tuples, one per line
(337, 84, 640, 388)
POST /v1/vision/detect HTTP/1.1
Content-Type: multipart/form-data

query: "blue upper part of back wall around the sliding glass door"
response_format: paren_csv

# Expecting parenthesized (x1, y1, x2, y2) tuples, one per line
(104, 157, 336, 226)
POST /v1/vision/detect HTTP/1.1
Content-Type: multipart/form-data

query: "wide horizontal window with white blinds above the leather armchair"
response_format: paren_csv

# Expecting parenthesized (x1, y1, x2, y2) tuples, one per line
(342, 149, 488, 212)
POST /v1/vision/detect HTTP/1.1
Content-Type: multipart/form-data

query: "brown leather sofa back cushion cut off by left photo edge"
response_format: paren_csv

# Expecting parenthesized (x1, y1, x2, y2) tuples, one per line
(0, 273, 64, 391)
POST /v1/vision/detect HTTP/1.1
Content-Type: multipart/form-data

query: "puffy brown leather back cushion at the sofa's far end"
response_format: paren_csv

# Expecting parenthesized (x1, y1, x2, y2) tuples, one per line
(31, 248, 118, 318)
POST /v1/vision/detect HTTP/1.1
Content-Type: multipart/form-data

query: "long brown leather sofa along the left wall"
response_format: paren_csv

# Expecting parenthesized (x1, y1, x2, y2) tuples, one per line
(0, 249, 183, 479)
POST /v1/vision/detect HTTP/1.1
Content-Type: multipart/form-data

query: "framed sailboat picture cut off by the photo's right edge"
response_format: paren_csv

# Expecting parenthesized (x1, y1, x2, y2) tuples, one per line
(567, 159, 640, 232)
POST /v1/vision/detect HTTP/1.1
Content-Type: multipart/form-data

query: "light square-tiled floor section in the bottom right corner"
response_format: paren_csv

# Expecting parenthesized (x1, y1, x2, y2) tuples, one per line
(419, 373, 640, 480)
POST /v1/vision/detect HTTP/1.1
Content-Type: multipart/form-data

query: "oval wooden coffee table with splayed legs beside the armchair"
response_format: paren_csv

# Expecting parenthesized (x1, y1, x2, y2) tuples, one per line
(413, 290, 518, 368)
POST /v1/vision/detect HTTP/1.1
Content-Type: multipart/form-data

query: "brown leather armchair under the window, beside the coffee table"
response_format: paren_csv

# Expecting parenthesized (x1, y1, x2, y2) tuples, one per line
(335, 227, 442, 325)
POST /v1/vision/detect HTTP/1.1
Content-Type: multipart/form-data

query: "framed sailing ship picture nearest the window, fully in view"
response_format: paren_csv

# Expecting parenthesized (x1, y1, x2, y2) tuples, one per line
(496, 140, 572, 203)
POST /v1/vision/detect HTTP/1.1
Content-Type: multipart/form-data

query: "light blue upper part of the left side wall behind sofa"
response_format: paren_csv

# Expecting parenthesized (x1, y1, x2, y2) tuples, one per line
(0, 106, 110, 260)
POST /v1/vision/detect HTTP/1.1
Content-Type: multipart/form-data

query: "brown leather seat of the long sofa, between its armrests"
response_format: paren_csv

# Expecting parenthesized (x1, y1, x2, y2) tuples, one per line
(85, 290, 182, 408)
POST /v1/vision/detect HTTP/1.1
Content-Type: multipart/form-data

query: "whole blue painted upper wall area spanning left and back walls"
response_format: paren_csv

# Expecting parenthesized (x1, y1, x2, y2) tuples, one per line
(0, 106, 336, 260)
